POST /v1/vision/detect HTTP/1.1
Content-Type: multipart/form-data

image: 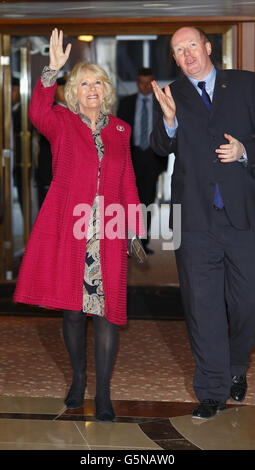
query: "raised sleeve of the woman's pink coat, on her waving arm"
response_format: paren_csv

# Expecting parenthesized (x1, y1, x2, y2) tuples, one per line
(28, 79, 61, 141)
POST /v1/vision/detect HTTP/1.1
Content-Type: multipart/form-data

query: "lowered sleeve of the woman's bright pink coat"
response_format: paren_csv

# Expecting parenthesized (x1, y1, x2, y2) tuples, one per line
(122, 126, 145, 237)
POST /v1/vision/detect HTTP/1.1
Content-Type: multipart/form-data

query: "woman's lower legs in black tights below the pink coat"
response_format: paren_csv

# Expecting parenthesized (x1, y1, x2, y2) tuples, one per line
(63, 310, 118, 421)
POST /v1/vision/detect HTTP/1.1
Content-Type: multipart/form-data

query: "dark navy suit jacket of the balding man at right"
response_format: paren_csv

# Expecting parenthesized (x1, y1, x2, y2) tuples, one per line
(151, 70, 255, 231)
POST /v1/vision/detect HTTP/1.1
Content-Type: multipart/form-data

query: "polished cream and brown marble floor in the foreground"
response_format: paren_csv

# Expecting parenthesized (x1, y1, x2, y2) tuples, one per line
(0, 396, 255, 454)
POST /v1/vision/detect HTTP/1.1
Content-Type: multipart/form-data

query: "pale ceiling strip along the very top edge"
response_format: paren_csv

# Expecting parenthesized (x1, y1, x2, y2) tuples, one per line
(0, 0, 255, 20)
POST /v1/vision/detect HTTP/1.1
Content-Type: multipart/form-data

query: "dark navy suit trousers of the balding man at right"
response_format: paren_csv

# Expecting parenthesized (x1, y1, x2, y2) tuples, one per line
(175, 209, 255, 401)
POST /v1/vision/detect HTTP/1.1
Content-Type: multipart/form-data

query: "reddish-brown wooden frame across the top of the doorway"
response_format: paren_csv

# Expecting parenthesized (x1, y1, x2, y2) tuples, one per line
(0, 16, 255, 72)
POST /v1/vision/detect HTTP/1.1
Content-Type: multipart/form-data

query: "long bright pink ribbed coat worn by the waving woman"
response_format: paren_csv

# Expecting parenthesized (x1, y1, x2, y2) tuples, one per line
(14, 80, 143, 325)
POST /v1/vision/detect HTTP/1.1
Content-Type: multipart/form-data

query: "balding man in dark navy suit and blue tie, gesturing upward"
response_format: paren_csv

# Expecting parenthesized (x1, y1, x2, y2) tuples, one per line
(151, 27, 255, 418)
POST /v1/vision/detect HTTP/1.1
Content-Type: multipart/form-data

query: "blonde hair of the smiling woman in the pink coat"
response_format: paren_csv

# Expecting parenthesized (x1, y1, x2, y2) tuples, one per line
(64, 62, 115, 114)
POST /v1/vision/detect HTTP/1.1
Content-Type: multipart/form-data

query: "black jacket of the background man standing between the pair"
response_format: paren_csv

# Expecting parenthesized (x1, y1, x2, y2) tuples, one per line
(117, 93, 168, 204)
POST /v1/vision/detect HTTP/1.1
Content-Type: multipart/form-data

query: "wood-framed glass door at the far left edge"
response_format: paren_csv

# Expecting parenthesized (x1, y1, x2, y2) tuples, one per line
(0, 35, 32, 282)
